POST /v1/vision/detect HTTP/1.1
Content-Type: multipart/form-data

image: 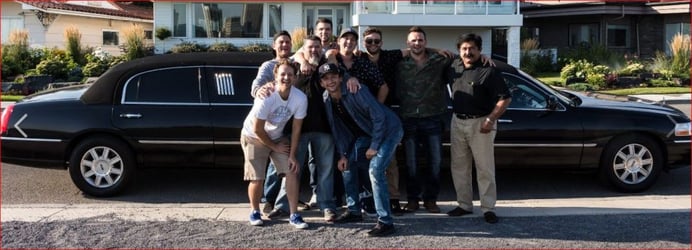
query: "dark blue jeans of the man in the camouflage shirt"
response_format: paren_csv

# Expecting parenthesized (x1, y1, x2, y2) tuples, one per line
(402, 115, 442, 201)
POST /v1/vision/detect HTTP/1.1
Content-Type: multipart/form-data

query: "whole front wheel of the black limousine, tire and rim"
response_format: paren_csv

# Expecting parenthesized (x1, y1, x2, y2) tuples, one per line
(600, 135, 664, 193)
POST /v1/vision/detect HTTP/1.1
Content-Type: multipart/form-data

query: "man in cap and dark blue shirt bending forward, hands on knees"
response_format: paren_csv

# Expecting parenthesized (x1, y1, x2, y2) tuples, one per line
(318, 64, 404, 236)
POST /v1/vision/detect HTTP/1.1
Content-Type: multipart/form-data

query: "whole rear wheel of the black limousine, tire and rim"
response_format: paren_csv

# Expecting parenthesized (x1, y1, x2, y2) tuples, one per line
(69, 137, 136, 197)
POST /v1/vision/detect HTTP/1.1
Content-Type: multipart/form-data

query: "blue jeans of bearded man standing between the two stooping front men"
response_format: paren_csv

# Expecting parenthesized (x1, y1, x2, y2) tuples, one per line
(274, 132, 336, 211)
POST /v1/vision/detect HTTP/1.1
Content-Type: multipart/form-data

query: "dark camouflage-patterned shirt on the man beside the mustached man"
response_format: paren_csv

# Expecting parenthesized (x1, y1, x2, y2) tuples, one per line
(396, 52, 452, 118)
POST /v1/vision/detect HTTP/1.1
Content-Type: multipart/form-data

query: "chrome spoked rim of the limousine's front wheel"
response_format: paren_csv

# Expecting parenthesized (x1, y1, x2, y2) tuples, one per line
(613, 143, 654, 184)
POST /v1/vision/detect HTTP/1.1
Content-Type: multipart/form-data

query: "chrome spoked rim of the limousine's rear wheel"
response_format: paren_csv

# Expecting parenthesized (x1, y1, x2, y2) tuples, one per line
(79, 146, 123, 188)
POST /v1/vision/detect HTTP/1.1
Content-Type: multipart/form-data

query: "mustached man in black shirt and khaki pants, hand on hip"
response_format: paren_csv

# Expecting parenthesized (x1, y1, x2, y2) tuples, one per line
(447, 34, 512, 223)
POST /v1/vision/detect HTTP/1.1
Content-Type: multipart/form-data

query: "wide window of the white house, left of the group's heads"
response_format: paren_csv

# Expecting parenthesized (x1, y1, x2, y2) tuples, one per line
(193, 3, 264, 38)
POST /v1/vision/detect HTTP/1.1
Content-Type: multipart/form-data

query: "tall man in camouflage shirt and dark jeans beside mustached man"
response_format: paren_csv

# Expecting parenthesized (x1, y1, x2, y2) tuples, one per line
(396, 26, 452, 213)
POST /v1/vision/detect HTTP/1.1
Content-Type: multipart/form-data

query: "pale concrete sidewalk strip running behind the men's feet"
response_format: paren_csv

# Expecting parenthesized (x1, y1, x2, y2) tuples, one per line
(0, 195, 690, 222)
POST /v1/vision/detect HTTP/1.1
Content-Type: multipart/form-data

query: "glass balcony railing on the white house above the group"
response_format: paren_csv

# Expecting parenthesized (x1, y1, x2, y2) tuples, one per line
(353, 0, 519, 15)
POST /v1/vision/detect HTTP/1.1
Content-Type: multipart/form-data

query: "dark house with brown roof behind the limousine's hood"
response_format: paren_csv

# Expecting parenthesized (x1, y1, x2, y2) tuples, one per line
(521, 1, 690, 58)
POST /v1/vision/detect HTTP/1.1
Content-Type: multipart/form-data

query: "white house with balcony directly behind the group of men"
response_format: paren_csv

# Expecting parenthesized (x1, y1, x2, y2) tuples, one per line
(154, 0, 522, 66)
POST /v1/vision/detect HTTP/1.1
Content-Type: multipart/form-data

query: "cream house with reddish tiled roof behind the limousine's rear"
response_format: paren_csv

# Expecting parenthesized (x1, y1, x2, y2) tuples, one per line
(0, 0, 154, 55)
